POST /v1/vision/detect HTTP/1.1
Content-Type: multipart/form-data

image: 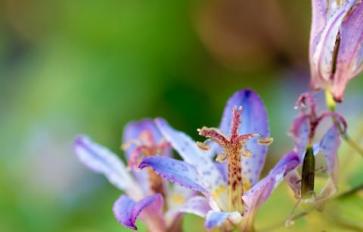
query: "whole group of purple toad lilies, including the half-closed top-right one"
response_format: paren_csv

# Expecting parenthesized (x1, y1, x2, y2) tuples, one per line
(75, 0, 363, 232)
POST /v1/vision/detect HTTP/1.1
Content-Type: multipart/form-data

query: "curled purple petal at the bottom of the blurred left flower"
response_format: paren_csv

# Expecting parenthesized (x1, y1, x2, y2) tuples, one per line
(113, 194, 165, 231)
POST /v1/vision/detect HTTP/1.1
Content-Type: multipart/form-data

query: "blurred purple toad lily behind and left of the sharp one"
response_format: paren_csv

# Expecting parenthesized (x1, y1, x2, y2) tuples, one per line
(75, 120, 193, 232)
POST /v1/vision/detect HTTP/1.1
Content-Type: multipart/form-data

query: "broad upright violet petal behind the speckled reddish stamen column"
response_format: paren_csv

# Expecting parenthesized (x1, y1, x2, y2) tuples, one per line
(220, 89, 270, 184)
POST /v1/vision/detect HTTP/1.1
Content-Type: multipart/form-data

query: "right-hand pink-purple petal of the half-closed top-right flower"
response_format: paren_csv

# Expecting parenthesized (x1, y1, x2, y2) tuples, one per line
(332, 2, 363, 101)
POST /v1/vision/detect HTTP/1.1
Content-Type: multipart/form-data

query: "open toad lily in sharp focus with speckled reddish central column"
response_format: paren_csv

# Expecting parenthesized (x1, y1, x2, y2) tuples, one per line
(140, 90, 299, 231)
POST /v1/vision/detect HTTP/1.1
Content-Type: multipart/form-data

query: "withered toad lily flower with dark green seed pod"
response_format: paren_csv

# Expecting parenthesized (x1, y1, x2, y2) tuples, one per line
(286, 93, 347, 202)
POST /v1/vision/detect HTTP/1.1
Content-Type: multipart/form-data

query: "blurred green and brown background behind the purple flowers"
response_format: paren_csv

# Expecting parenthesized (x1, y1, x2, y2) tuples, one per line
(0, 0, 363, 232)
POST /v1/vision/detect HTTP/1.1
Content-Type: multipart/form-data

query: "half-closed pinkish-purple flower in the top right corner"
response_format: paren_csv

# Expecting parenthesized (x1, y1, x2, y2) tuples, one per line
(310, 0, 363, 102)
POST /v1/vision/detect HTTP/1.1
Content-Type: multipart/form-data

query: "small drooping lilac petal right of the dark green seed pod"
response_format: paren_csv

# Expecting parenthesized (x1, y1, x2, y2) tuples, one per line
(319, 126, 340, 183)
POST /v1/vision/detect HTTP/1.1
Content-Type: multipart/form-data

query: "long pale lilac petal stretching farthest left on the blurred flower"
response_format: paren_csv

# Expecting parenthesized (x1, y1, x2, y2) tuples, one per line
(74, 136, 141, 197)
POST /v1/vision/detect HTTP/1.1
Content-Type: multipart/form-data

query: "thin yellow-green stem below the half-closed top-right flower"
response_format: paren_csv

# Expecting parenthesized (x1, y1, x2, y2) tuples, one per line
(325, 90, 363, 158)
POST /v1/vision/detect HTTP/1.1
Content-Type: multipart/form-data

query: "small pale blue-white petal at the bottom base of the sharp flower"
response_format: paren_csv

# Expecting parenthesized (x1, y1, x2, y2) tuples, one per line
(204, 211, 242, 229)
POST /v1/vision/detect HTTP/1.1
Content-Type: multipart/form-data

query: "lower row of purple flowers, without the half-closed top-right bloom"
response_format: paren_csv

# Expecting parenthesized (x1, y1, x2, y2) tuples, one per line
(75, 89, 339, 231)
